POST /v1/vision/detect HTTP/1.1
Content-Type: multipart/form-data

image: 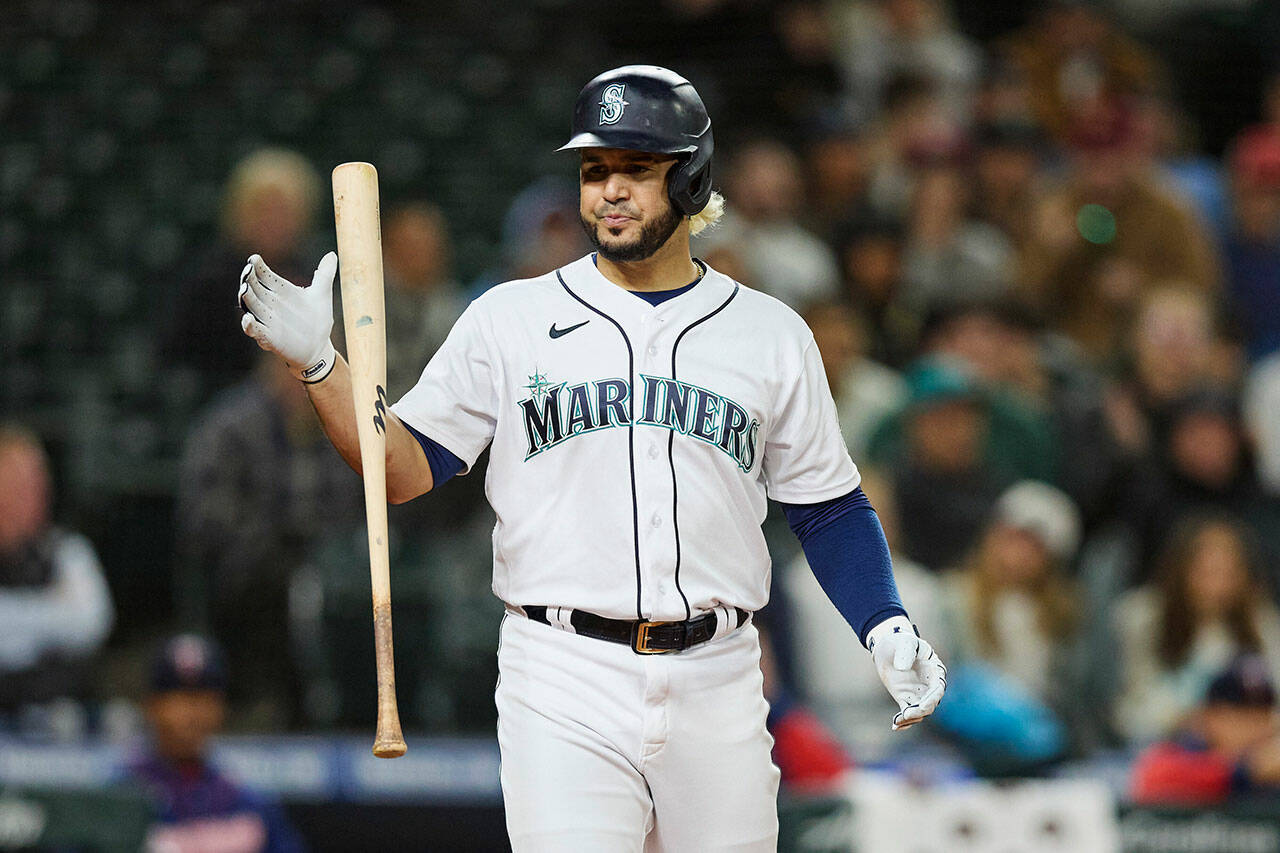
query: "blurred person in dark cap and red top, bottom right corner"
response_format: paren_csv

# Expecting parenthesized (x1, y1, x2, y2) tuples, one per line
(1130, 656, 1280, 806)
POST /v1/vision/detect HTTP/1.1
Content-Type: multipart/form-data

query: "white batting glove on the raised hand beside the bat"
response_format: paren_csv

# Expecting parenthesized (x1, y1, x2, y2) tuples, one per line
(238, 252, 338, 382)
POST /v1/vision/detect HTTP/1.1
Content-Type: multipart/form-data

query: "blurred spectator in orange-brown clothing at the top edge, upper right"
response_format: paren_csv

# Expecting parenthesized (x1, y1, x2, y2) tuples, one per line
(1000, 0, 1162, 141)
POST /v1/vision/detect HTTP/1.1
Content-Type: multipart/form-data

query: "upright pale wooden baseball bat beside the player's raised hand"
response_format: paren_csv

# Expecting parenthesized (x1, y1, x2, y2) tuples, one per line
(333, 163, 406, 758)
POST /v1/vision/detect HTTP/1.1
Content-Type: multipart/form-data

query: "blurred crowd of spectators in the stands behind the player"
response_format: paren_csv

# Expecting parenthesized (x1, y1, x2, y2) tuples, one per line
(0, 0, 1280, 814)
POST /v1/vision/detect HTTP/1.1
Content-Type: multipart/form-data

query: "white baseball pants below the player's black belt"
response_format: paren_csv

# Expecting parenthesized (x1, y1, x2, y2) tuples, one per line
(497, 613, 778, 853)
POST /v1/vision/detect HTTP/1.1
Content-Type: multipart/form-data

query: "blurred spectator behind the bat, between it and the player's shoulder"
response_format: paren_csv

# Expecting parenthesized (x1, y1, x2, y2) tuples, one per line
(335, 202, 466, 401)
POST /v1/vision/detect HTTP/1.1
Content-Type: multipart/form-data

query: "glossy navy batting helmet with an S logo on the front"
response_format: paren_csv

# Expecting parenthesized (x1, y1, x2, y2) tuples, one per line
(559, 65, 716, 216)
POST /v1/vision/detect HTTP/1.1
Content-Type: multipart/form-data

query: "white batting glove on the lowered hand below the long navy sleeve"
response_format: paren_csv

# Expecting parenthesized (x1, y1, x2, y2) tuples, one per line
(867, 616, 947, 731)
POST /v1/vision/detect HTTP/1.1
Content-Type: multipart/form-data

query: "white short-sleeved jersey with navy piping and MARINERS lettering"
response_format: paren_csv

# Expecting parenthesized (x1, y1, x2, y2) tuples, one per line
(392, 256, 859, 620)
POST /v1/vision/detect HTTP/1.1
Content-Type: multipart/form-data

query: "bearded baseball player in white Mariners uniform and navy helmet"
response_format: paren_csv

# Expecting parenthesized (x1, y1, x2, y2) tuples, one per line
(239, 65, 946, 852)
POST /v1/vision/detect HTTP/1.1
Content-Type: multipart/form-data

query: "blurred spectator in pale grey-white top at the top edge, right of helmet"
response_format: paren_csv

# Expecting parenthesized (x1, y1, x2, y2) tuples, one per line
(832, 0, 982, 124)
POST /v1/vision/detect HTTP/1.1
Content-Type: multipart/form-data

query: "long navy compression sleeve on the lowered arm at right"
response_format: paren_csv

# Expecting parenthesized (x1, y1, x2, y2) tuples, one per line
(782, 487, 906, 646)
